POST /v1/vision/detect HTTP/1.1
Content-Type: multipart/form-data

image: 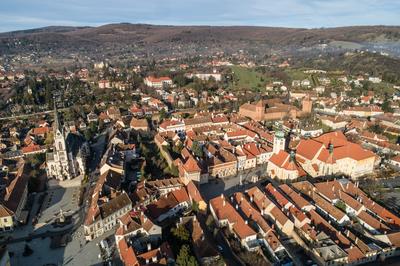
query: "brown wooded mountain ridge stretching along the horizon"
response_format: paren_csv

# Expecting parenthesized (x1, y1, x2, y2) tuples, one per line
(0, 23, 400, 60)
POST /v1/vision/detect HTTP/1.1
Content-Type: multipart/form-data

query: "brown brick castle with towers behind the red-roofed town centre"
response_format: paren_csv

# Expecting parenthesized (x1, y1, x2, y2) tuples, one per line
(239, 98, 312, 121)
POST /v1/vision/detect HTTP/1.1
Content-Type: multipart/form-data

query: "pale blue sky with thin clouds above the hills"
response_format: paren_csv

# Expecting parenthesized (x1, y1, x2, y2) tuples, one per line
(0, 0, 400, 32)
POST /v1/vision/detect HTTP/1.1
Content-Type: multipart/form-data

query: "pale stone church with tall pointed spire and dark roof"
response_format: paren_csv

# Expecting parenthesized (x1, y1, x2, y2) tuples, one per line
(46, 109, 89, 180)
